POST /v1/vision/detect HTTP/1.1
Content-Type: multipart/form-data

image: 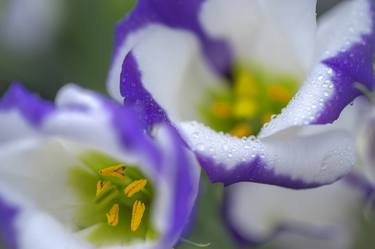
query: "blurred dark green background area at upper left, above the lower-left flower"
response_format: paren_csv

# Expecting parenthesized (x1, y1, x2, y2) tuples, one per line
(0, 0, 135, 98)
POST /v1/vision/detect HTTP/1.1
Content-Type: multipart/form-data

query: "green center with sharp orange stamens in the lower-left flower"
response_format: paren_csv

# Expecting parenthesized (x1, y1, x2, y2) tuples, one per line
(70, 152, 158, 245)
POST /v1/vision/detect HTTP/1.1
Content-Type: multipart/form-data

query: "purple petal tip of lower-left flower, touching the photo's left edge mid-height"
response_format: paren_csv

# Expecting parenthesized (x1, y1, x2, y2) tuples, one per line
(0, 82, 53, 126)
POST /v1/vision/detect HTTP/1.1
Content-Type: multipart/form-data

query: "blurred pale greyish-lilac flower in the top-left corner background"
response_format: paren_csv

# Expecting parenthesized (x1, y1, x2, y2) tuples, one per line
(0, 0, 64, 53)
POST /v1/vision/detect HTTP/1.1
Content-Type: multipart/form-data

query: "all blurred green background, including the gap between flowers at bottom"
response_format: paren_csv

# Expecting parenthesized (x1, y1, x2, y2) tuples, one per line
(0, 0, 375, 249)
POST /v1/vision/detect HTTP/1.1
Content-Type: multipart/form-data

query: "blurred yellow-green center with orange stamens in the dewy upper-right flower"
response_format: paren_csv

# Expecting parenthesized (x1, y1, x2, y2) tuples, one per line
(198, 66, 298, 137)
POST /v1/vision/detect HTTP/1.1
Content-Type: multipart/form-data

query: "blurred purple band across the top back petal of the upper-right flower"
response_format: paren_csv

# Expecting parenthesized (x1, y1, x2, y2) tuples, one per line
(113, 0, 233, 75)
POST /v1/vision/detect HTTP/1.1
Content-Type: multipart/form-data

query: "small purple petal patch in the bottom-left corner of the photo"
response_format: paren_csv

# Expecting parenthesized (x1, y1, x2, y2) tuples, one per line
(0, 198, 19, 249)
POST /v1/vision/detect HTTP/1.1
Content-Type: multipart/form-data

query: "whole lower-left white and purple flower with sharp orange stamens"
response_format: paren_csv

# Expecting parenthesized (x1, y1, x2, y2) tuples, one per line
(0, 84, 199, 249)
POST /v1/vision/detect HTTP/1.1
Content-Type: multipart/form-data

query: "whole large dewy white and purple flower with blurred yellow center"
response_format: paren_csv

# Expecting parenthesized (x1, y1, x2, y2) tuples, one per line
(108, 0, 375, 188)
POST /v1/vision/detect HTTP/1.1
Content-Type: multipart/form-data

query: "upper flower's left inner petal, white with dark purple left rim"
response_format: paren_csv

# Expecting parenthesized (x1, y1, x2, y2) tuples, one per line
(121, 25, 220, 125)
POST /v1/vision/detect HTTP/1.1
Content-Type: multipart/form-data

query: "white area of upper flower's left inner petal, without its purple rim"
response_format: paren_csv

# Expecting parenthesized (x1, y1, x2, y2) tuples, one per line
(132, 25, 218, 121)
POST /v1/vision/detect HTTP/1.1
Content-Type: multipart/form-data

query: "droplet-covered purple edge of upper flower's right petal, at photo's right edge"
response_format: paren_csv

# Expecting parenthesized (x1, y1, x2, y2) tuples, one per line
(313, 1, 375, 124)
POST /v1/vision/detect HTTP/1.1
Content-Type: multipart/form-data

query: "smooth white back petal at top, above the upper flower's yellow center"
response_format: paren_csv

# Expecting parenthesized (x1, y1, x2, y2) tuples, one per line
(200, 0, 316, 76)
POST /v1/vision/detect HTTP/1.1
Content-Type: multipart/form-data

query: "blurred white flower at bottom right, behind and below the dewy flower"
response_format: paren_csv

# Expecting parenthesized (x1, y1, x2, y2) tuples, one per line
(223, 98, 375, 249)
